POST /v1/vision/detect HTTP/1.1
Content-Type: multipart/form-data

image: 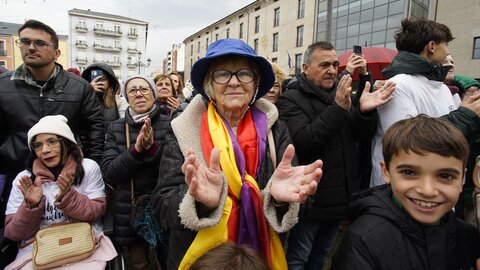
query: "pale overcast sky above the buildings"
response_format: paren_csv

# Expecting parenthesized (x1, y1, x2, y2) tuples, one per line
(0, 0, 255, 66)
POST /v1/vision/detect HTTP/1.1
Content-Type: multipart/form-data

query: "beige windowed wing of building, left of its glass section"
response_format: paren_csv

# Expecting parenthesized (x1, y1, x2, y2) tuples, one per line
(184, 0, 316, 81)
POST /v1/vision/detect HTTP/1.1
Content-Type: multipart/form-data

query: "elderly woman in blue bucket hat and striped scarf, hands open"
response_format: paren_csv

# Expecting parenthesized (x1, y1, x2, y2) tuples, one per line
(153, 39, 322, 269)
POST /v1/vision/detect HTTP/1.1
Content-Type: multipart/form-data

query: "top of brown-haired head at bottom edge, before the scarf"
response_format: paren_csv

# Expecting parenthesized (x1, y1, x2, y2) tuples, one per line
(190, 243, 269, 270)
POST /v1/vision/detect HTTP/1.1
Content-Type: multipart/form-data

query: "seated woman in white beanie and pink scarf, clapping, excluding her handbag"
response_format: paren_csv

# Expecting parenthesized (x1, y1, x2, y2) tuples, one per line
(4, 115, 117, 269)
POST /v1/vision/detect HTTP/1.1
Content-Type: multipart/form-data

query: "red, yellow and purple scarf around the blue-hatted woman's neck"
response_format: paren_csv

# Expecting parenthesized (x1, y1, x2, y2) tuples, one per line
(179, 102, 288, 270)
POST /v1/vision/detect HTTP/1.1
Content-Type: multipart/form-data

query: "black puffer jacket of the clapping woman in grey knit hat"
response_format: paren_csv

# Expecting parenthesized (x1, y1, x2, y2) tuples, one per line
(101, 107, 170, 246)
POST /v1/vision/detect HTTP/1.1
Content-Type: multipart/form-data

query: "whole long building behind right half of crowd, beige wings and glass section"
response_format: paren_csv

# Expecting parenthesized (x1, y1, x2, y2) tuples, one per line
(184, 0, 480, 79)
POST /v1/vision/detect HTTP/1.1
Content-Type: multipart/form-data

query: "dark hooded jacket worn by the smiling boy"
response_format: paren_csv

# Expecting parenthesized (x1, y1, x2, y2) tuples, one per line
(332, 185, 480, 270)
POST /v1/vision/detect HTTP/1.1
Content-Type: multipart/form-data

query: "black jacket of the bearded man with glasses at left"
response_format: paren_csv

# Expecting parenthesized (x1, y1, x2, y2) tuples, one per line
(0, 64, 105, 177)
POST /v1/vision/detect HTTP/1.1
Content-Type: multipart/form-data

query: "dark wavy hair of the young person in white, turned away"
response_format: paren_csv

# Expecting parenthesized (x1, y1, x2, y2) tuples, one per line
(395, 18, 454, 54)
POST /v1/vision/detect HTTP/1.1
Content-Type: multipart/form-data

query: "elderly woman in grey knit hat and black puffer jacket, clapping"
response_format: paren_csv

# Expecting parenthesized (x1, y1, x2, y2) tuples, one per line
(101, 75, 170, 269)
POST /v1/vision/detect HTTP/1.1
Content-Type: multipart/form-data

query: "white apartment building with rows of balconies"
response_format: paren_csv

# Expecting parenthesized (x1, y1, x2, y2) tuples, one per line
(68, 9, 149, 79)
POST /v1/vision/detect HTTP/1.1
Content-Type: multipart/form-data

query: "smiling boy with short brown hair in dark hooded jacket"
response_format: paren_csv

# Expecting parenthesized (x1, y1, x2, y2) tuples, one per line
(332, 115, 480, 270)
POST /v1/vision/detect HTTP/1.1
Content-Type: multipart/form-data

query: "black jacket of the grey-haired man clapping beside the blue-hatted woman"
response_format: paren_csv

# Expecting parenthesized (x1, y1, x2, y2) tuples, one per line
(278, 74, 377, 221)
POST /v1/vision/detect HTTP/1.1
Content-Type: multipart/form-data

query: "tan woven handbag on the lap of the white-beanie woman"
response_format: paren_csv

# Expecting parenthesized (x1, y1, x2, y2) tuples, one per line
(32, 222, 95, 269)
